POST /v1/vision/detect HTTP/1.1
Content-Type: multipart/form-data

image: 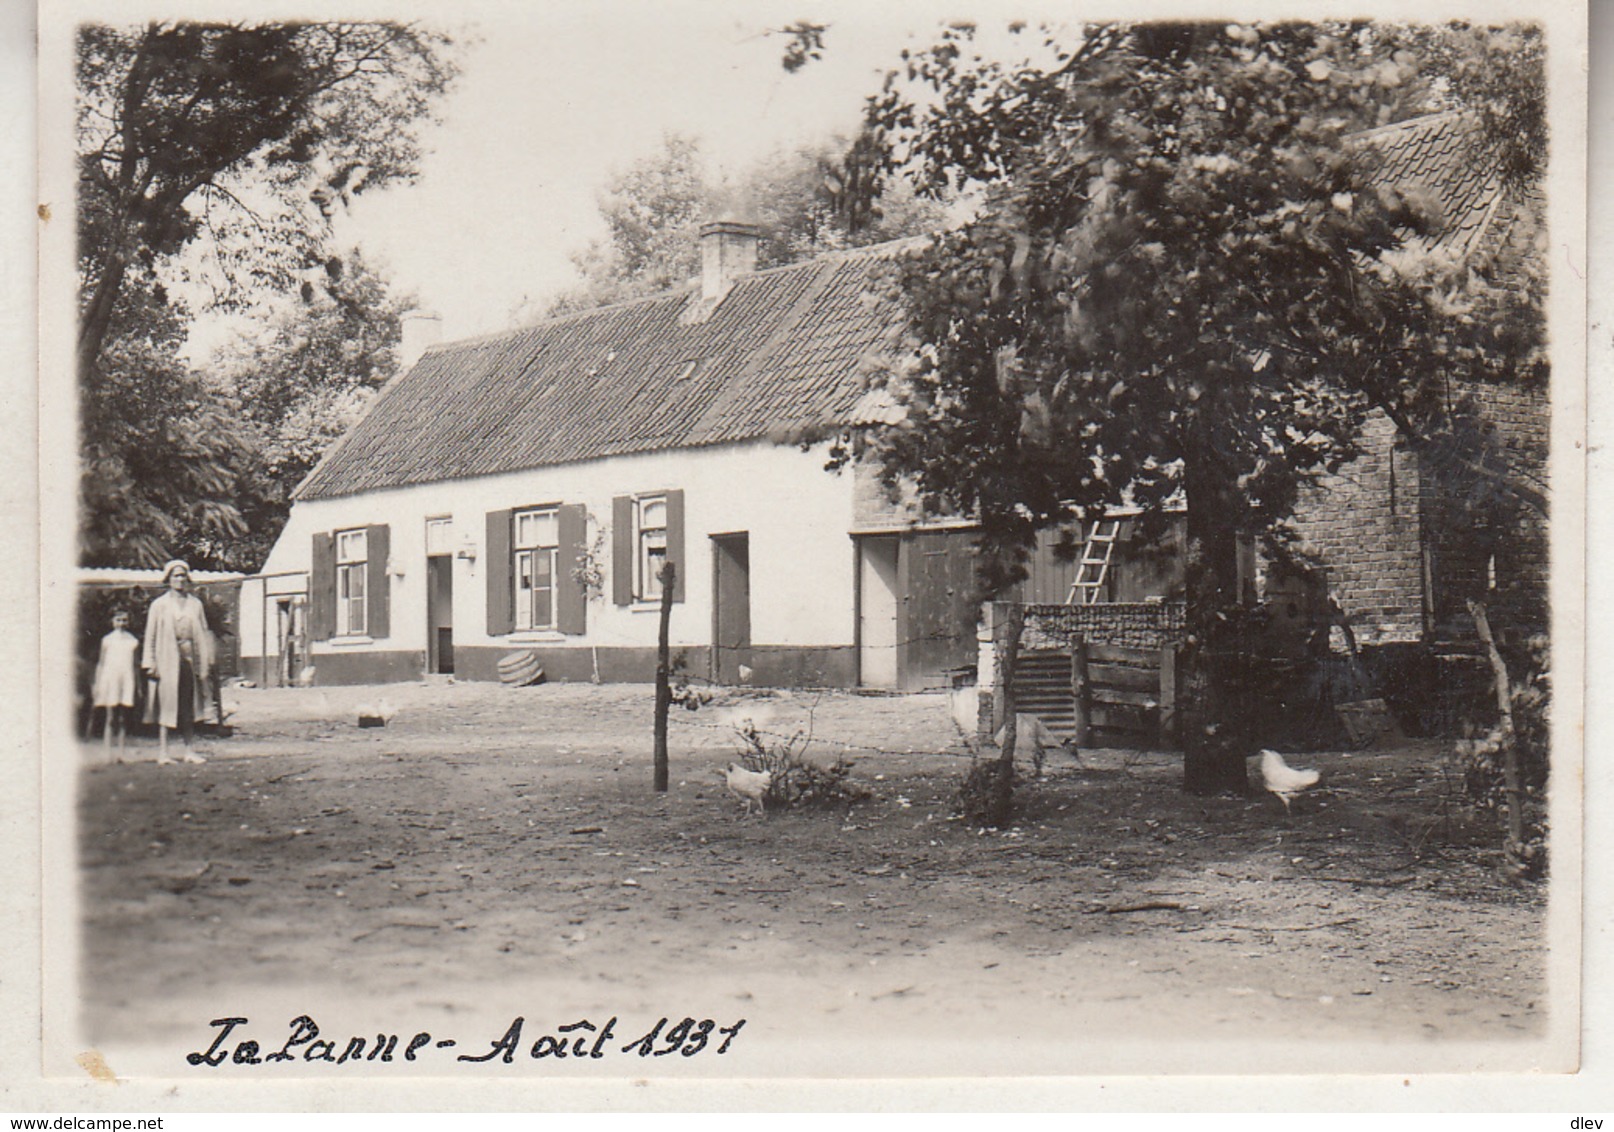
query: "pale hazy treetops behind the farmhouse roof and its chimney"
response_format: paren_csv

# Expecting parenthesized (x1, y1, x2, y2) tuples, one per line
(515, 134, 943, 320)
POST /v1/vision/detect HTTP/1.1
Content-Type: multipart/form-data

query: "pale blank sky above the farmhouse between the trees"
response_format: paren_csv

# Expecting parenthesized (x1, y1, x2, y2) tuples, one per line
(339, 0, 987, 339)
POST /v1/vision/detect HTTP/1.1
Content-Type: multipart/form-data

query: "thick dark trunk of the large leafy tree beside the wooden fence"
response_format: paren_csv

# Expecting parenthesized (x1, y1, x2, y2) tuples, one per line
(1178, 425, 1249, 794)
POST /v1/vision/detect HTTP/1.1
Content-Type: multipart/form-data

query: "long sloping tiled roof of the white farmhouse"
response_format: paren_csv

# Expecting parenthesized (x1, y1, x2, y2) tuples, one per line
(297, 244, 901, 499)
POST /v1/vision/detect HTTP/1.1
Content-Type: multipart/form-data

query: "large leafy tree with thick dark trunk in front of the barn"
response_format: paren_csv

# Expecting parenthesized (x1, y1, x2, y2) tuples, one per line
(843, 23, 1545, 793)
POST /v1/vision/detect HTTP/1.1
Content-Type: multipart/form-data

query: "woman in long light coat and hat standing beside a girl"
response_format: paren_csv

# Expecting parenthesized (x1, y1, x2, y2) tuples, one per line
(140, 559, 213, 764)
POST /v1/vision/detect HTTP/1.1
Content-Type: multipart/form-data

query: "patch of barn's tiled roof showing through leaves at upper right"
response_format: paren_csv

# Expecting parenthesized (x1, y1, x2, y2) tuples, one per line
(1353, 111, 1511, 255)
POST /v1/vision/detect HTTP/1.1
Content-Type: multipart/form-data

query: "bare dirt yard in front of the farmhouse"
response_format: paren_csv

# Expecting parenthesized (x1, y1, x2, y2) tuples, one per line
(79, 685, 1546, 1075)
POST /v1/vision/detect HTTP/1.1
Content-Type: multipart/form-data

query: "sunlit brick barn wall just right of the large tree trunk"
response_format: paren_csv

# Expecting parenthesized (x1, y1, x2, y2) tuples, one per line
(1293, 413, 1425, 644)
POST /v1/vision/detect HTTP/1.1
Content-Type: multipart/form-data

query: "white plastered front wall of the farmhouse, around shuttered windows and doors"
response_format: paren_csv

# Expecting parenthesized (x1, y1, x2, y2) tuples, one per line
(242, 441, 855, 656)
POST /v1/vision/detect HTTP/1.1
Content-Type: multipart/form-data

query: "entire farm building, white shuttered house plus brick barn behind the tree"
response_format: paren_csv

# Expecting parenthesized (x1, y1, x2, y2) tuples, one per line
(240, 116, 1546, 713)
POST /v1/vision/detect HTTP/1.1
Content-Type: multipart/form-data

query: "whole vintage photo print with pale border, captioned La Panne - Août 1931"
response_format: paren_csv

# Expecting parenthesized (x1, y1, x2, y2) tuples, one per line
(40, 2, 1585, 1084)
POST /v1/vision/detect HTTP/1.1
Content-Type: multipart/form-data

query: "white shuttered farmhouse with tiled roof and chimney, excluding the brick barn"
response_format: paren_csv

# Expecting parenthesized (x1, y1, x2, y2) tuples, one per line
(242, 223, 973, 686)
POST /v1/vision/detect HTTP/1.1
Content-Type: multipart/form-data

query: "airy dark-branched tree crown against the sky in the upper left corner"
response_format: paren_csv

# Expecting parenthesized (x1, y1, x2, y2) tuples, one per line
(77, 23, 455, 375)
